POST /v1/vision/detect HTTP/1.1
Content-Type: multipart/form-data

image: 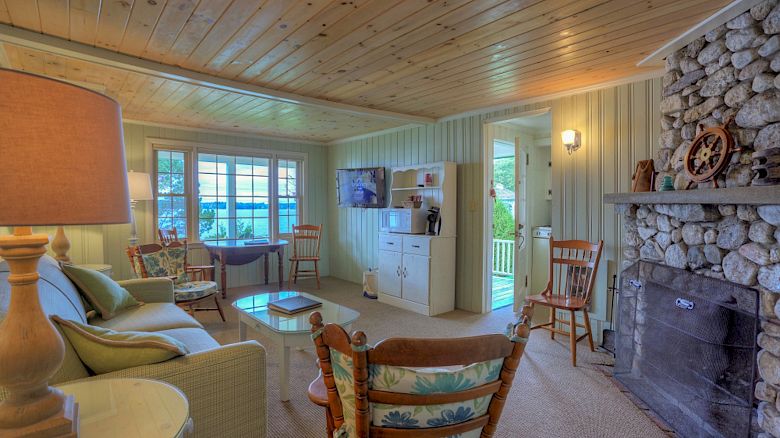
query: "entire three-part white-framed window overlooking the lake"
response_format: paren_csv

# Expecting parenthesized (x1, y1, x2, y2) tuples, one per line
(153, 141, 304, 241)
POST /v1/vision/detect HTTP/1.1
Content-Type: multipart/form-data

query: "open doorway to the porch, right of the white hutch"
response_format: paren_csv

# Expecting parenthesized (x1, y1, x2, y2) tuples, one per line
(483, 110, 552, 311)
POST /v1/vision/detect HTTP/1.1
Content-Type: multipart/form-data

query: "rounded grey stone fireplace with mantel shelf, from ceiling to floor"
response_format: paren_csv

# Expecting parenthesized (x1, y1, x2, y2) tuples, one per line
(605, 0, 780, 438)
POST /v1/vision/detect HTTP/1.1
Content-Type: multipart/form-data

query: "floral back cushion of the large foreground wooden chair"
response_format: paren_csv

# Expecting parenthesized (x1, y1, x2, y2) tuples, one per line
(331, 349, 503, 438)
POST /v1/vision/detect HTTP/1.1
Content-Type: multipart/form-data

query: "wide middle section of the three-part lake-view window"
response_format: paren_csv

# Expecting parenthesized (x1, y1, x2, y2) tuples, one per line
(198, 153, 271, 241)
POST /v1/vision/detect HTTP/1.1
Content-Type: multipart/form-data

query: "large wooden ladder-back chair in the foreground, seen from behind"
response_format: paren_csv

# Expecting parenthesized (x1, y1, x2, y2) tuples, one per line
(309, 306, 532, 438)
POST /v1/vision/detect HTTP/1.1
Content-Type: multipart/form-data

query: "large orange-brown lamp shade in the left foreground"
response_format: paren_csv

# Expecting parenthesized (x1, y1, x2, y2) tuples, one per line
(0, 69, 130, 226)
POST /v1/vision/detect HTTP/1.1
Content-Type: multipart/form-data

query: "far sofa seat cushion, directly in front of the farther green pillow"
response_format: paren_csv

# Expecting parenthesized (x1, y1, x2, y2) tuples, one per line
(89, 303, 203, 332)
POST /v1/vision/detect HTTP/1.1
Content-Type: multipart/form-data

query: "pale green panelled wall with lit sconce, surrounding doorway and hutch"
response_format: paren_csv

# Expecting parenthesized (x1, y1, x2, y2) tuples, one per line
(327, 79, 661, 319)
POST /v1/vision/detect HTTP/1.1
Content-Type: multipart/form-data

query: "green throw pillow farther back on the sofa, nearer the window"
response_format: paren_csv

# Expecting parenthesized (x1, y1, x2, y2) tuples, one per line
(62, 265, 141, 320)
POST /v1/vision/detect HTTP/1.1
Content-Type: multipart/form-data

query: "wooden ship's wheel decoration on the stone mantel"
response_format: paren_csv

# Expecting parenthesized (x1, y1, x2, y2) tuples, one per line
(685, 118, 742, 188)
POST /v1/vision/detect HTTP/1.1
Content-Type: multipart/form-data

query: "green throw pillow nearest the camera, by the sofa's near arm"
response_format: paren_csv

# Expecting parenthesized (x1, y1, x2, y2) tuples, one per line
(52, 316, 189, 374)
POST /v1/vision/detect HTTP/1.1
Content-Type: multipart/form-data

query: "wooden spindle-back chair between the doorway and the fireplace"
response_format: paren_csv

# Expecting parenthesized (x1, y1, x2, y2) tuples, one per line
(526, 237, 604, 367)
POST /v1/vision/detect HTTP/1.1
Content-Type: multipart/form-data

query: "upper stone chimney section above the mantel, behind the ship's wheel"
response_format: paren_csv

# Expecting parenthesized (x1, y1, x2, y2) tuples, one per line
(655, 0, 780, 190)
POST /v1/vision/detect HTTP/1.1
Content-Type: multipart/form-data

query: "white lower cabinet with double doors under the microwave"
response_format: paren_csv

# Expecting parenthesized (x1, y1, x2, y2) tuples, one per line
(379, 233, 455, 316)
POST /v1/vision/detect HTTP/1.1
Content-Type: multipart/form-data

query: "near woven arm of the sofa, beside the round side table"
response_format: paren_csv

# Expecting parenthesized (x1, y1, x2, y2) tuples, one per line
(80, 341, 268, 438)
